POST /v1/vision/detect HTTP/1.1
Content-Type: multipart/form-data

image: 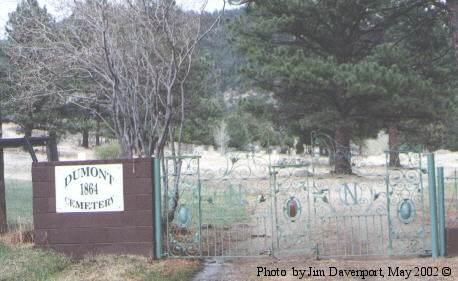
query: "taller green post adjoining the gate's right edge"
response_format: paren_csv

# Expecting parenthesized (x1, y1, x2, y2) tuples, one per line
(428, 153, 438, 258)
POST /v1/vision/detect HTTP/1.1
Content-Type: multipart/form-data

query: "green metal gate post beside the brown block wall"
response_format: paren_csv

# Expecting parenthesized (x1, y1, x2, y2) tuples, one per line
(153, 158, 162, 259)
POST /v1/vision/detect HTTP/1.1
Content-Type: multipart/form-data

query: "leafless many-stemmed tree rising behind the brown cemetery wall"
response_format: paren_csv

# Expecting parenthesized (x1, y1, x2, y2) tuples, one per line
(30, 0, 225, 158)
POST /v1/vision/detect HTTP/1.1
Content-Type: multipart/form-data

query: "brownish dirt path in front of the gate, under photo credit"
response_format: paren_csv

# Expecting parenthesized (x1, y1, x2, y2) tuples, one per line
(193, 258, 458, 281)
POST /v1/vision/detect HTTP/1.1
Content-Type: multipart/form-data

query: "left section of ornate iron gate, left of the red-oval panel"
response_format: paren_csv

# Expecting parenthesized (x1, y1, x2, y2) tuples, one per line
(163, 153, 273, 257)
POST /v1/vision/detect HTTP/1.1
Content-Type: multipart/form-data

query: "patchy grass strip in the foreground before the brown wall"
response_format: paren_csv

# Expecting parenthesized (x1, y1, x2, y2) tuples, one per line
(0, 243, 201, 281)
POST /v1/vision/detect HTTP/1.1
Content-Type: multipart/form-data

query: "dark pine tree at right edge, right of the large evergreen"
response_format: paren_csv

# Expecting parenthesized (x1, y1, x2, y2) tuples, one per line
(377, 2, 458, 154)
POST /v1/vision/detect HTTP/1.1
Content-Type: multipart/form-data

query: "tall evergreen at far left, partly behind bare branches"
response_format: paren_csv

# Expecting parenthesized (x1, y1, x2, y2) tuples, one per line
(5, 0, 59, 136)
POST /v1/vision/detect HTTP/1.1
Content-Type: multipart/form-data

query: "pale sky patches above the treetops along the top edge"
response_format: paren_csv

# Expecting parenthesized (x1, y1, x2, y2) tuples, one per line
(0, 0, 233, 37)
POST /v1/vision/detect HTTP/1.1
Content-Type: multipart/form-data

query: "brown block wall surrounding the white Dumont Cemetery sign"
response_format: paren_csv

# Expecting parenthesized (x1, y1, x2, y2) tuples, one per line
(32, 159, 154, 257)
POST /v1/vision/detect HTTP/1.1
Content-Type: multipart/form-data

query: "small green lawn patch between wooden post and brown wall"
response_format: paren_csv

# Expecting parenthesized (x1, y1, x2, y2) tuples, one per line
(6, 179, 33, 230)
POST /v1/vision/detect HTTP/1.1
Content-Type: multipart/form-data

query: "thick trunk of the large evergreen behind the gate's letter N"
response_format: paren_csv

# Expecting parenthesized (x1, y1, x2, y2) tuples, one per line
(334, 126, 352, 175)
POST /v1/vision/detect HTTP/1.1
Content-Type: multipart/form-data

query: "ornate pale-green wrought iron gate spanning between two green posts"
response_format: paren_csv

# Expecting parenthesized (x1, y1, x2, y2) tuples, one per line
(163, 152, 429, 257)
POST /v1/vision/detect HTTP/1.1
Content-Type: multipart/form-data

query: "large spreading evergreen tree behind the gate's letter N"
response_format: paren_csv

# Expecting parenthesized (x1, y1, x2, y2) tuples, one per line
(234, 0, 438, 174)
